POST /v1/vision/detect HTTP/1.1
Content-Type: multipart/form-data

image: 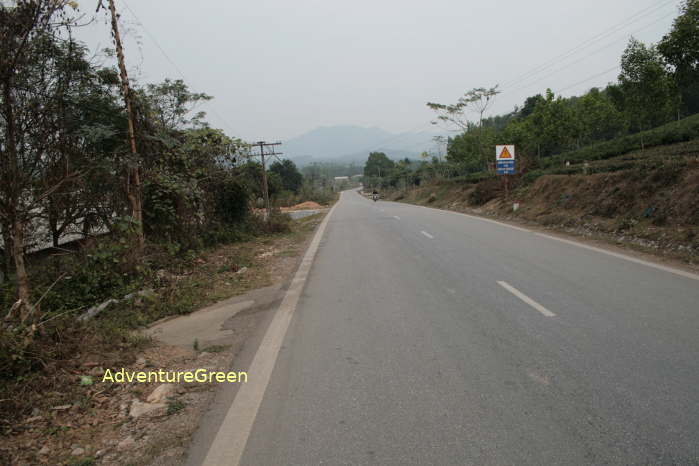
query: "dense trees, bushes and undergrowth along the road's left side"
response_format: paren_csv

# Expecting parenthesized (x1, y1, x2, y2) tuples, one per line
(0, 0, 335, 434)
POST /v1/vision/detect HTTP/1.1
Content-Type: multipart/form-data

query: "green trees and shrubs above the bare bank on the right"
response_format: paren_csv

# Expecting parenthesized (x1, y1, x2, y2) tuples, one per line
(364, 0, 699, 188)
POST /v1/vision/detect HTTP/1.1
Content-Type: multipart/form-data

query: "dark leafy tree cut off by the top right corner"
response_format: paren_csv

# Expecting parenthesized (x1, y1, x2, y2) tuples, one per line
(658, 0, 699, 114)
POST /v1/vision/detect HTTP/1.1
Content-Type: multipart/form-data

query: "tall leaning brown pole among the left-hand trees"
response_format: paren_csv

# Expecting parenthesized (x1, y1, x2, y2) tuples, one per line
(104, 0, 145, 253)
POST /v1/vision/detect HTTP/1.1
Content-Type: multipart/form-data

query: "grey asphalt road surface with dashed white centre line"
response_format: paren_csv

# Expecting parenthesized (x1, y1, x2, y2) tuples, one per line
(234, 192, 699, 465)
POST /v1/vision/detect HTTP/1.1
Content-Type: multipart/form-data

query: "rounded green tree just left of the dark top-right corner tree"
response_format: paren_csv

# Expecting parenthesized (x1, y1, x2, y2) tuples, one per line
(619, 38, 679, 137)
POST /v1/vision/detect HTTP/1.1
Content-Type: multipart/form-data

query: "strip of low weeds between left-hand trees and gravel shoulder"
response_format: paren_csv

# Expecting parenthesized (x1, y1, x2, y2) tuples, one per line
(0, 213, 328, 435)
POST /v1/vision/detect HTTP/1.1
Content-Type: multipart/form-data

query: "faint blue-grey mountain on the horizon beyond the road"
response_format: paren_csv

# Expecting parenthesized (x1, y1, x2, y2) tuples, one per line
(282, 126, 441, 166)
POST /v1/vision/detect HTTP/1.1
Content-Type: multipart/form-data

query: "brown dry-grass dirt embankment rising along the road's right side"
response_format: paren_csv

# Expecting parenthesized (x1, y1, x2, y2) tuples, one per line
(391, 149, 699, 265)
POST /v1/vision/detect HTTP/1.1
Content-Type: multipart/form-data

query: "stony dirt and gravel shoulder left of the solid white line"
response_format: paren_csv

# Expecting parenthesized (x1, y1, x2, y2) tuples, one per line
(0, 215, 323, 465)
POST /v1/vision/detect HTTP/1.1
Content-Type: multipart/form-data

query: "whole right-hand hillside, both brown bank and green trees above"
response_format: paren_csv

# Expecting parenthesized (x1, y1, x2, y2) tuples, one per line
(364, 0, 699, 262)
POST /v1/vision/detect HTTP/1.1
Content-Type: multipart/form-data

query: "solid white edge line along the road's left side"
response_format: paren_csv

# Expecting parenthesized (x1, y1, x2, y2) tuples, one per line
(203, 202, 339, 466)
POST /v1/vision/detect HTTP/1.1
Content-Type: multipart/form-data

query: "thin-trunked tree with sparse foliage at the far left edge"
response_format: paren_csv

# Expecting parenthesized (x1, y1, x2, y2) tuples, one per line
(0, 0, 78, 322)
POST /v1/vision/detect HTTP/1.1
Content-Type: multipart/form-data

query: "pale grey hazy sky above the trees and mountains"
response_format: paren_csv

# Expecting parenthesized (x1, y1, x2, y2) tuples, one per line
(79, 0, 680, 140)
